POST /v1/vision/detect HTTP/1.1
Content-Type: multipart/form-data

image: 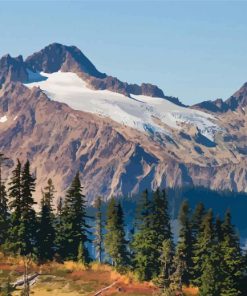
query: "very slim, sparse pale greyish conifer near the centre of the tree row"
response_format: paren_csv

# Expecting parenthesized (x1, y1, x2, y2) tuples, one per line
(94, 196, 104, 263)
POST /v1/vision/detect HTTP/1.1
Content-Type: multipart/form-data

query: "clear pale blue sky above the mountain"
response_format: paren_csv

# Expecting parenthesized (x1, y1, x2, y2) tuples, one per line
(0, 0, 247, 104)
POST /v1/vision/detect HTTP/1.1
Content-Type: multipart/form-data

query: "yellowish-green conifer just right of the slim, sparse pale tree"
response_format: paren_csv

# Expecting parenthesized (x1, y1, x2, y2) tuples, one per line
(105, 198, 129, 270)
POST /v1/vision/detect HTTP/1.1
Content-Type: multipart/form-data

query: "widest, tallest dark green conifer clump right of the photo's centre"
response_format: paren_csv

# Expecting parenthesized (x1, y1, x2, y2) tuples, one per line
(132, 189, 172, 280)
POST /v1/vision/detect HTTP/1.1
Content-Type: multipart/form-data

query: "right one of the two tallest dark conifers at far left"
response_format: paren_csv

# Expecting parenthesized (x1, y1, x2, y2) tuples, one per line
(19, 161, 37, 255)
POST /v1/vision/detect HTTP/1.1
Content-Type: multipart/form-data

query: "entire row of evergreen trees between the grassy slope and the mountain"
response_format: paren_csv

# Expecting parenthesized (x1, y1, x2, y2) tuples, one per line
(0, 154, 247, 296)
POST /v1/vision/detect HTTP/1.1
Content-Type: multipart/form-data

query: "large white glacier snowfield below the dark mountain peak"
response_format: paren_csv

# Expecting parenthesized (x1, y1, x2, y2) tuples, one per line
(26, 72, 220, 141)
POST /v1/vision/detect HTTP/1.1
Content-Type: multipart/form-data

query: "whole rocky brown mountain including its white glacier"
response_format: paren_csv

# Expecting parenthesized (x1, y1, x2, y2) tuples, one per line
(0, 43, 247, 201)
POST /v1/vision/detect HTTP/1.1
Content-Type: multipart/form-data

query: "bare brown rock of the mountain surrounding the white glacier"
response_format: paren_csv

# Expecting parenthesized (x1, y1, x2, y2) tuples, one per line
(0, 45, 247, 201)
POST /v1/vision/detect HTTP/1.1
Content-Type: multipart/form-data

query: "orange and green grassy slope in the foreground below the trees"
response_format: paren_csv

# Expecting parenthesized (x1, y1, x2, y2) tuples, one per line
(0, 256, 197, 296)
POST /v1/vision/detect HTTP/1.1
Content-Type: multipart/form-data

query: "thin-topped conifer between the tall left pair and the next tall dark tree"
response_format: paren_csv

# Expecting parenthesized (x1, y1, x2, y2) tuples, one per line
(38, 179, 55, 262)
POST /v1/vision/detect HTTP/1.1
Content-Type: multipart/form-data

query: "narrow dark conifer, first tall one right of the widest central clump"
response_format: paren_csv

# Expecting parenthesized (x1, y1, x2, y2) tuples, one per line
(177, 201, 193, 285)
